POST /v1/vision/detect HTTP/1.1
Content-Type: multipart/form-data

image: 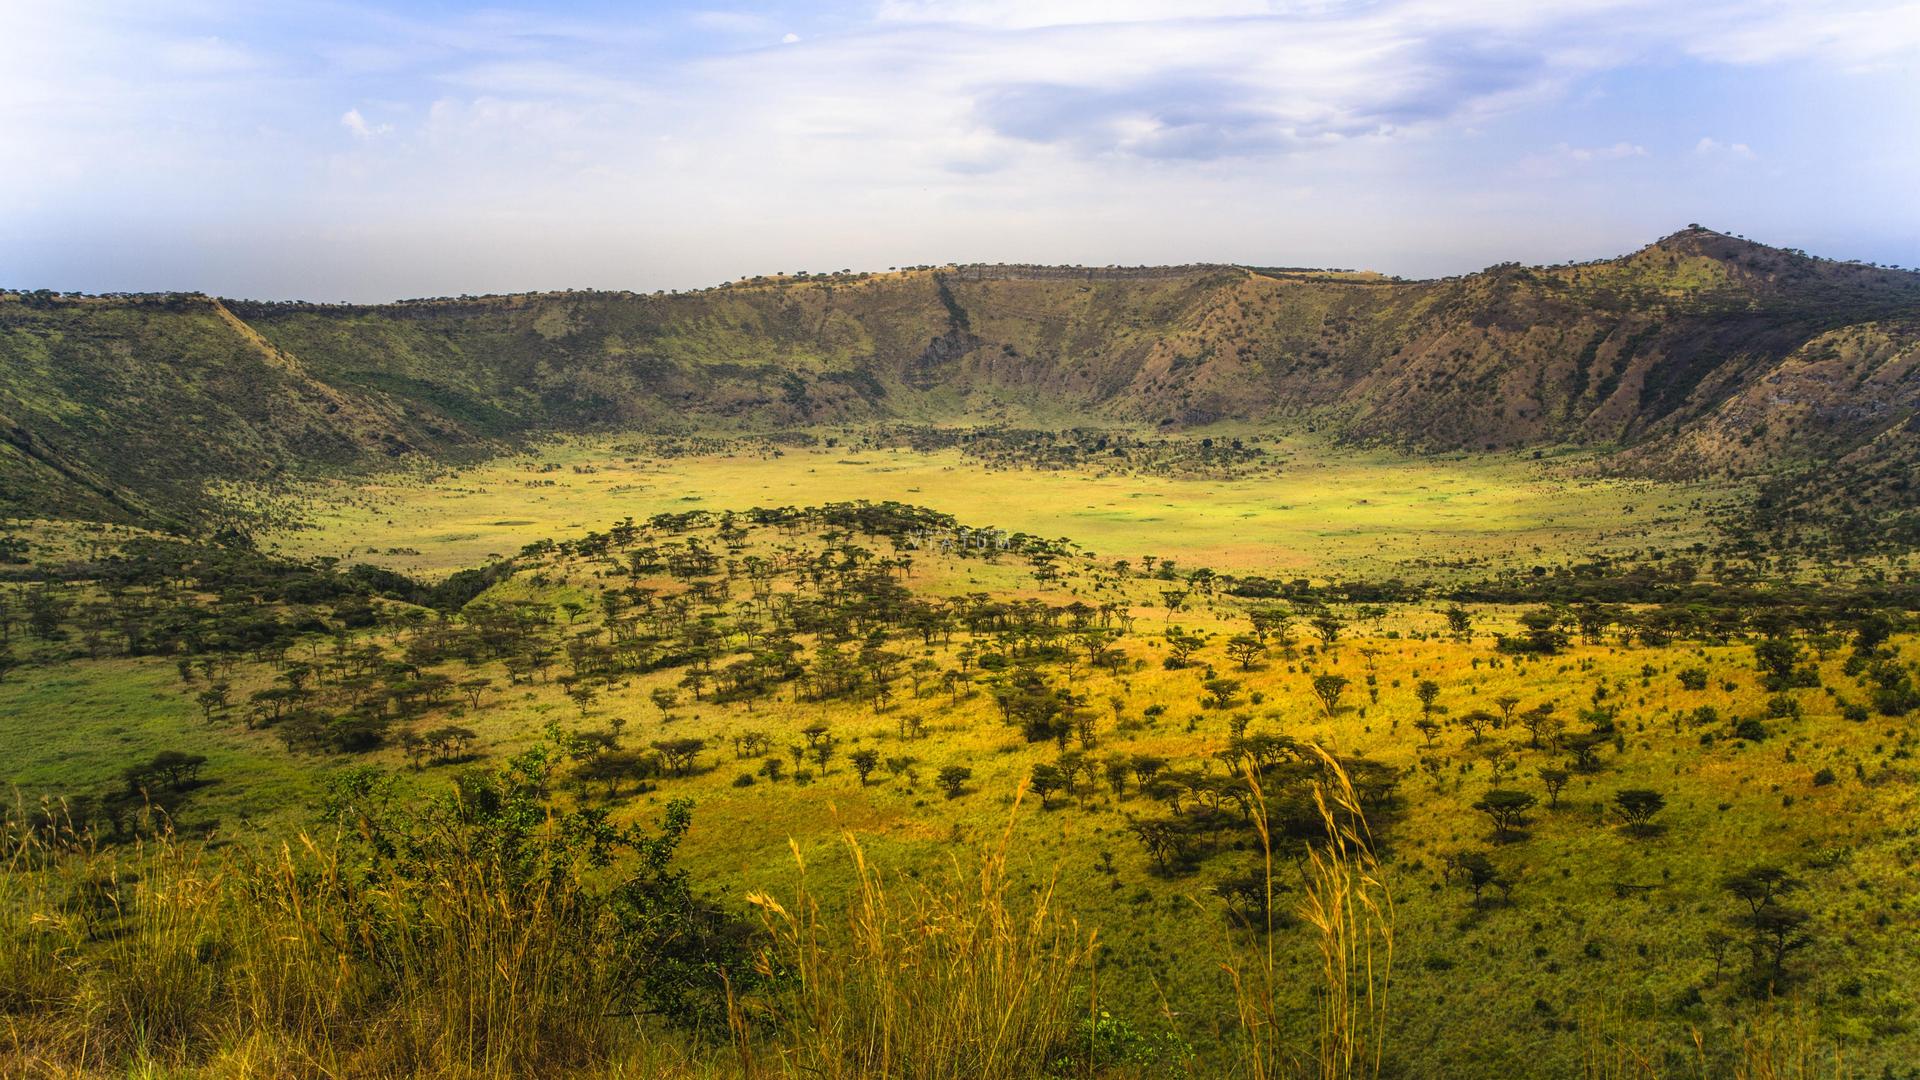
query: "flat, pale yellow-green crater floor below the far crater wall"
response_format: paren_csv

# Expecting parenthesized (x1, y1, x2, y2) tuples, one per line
(247, 428, 1740, 578)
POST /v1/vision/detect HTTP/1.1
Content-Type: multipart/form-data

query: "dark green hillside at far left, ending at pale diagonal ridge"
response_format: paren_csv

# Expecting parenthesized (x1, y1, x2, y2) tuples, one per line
(0, 296, 478, 523)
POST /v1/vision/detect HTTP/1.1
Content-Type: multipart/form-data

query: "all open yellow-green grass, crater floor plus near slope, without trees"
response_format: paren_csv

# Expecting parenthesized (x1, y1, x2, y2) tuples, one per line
(0, 438, 1920, 1076)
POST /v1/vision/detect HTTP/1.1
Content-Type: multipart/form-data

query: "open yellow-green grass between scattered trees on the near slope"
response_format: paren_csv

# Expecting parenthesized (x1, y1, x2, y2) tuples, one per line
(11, 534, 1920, 1076)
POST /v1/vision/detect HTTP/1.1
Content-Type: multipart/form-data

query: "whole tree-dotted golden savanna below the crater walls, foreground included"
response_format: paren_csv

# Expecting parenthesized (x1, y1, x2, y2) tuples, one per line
(0, 425, 1920, 1078)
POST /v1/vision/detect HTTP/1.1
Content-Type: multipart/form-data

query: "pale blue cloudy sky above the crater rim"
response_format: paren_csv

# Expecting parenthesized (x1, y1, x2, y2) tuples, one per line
(0, 0, 1920, 302)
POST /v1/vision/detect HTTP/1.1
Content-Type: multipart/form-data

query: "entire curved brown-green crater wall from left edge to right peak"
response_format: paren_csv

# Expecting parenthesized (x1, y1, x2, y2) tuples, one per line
(0, 227, 1920, 530)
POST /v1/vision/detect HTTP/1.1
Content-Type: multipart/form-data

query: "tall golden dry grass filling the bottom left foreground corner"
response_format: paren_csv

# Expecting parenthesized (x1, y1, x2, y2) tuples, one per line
(0, 795, 714, 1078)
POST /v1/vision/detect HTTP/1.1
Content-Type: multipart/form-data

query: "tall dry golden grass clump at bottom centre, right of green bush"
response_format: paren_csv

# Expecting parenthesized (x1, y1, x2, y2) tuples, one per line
(735, 780, 1096, 1080)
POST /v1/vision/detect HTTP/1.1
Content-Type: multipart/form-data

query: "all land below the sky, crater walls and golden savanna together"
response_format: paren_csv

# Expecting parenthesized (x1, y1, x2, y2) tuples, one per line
(0, 225, 1920, 1080)
